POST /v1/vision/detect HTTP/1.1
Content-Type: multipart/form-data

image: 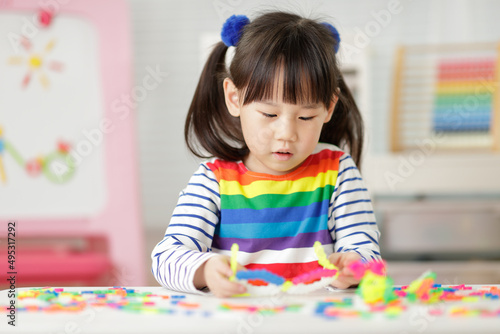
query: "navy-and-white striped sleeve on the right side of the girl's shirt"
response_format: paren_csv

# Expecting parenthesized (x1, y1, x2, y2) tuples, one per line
(328, 154, 381, 260)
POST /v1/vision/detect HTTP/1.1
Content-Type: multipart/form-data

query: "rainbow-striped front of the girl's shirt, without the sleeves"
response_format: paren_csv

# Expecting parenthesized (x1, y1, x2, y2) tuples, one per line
(207, 149, 344, 278)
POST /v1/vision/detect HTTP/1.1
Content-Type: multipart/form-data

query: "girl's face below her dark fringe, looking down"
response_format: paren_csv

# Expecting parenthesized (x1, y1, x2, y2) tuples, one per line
(224, 79, 336, 175)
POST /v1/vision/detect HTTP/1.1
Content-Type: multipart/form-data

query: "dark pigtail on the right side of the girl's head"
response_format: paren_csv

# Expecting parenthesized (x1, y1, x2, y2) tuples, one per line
(320, 73, 364, 168)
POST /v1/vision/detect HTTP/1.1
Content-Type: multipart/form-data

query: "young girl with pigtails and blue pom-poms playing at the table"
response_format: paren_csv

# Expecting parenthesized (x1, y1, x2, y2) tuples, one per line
(151, 12, 380, 297)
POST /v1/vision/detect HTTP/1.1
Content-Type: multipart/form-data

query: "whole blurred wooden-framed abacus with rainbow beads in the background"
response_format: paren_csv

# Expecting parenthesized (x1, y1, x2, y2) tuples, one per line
(390, 43, 500, 152)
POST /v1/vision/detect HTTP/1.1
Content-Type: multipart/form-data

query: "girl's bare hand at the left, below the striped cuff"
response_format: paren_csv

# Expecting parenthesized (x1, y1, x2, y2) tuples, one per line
(194, 255, 246, 298)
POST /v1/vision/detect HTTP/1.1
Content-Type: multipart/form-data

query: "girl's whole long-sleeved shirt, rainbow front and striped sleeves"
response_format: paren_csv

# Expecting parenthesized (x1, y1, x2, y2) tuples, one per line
(152, 144, 380, 292)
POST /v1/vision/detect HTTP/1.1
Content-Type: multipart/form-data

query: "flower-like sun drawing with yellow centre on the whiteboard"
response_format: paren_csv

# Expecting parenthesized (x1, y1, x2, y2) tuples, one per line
(8, 37, 63, 89)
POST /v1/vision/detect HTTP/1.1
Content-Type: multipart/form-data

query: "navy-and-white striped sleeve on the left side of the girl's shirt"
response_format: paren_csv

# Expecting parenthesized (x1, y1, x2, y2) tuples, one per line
(151, 164, 220, 293)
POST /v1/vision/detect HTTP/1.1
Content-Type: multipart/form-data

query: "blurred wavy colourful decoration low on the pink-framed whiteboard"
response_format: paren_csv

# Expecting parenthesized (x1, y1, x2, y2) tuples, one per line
(0, 126, 76, 184)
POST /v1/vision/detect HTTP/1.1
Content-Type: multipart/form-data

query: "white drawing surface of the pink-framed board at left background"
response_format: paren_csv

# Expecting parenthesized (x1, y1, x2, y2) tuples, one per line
(0, 11, 107, 219)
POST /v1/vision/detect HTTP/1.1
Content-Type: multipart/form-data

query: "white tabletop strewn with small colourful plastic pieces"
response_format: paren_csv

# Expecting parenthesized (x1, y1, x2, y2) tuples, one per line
(0, 286, 500, 334)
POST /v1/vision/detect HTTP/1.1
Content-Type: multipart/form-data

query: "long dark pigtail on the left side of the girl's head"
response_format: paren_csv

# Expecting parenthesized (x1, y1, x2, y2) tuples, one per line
(184, 42, 248, 161)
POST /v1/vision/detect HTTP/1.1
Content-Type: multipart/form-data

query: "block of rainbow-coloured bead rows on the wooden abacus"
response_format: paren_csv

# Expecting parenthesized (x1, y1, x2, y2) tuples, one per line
(432, 58, 497, 133)
